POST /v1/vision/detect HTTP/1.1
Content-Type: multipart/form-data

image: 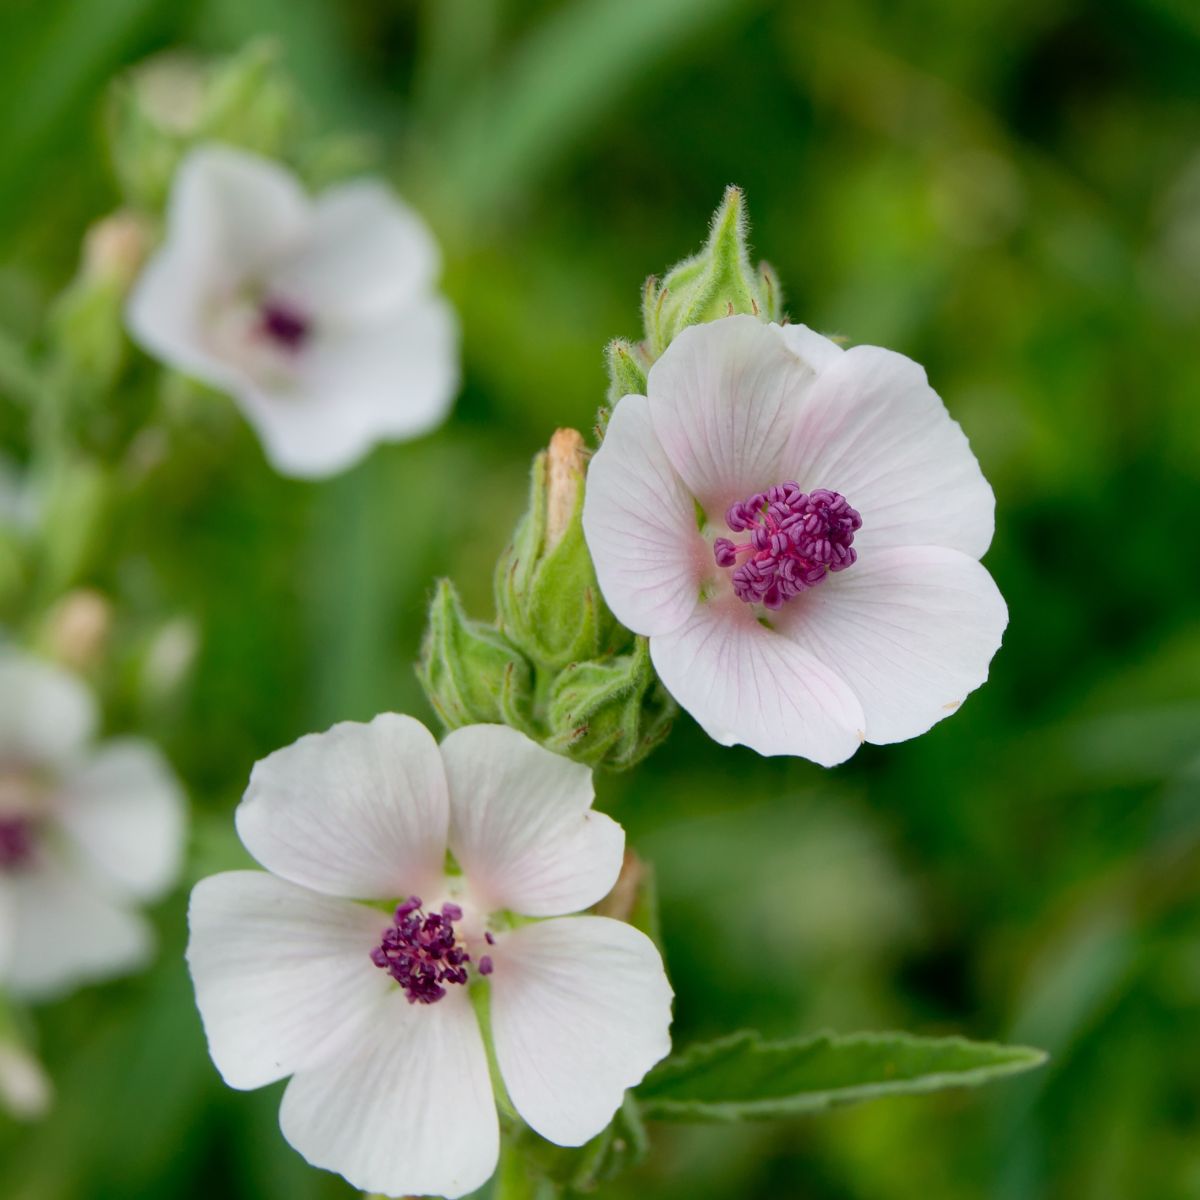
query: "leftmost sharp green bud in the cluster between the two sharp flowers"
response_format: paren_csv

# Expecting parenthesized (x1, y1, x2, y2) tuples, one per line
(416, 580, 533, 732)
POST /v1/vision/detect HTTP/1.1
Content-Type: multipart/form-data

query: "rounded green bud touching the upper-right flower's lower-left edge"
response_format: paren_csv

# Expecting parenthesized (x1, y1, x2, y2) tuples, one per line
(546, 637, 676, 770)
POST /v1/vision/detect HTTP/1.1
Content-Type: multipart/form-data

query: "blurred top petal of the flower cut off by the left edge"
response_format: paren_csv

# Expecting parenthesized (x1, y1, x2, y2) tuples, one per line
(0, 650, 96, 766)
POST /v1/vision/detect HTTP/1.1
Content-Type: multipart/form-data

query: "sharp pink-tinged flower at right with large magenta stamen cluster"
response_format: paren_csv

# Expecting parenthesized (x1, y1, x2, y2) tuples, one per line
(583, 317, 1008, 766)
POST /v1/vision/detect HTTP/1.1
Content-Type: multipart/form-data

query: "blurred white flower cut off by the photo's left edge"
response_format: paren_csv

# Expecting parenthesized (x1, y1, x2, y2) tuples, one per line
(0, 648, 184, 997)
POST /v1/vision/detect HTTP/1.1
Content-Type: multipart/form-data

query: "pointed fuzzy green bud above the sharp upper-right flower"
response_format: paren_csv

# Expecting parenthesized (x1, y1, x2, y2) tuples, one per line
(638, 187, 781, 362)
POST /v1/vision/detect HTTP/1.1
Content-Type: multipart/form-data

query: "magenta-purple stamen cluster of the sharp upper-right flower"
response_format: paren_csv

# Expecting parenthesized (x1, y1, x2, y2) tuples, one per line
(713, 482, 863, 608)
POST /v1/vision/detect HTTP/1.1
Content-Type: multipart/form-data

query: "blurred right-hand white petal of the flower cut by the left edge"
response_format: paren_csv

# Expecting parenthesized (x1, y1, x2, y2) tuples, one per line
(59, 738, 186, 899)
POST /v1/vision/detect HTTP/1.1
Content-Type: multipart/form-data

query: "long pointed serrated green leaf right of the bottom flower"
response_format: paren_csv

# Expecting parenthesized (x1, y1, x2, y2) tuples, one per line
(637, 1031, 1046, 1121)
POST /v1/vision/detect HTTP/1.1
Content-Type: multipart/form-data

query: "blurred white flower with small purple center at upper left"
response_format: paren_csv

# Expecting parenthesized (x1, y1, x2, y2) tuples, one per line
(128, 145, 458, 478)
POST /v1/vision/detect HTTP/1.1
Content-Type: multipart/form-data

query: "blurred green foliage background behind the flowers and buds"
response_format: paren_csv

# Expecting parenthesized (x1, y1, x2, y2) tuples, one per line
(0, 0, 1200, 1200)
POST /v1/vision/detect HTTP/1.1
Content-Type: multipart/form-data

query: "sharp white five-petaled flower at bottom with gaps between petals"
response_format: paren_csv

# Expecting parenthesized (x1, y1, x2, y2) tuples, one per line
(187, 714, 671, 1196)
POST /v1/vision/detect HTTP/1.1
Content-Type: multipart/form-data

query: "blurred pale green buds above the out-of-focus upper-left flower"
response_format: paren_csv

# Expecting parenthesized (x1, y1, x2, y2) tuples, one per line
(107, 41, 299, 210)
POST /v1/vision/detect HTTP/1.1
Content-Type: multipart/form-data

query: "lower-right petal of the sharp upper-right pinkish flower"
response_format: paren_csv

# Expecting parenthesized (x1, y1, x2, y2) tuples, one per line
(780, 546, 1008, 744)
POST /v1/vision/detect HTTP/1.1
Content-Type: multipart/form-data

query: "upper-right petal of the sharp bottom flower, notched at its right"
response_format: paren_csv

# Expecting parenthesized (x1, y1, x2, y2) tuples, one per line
(442, 725, 625, 917)
